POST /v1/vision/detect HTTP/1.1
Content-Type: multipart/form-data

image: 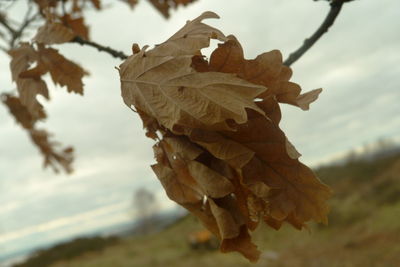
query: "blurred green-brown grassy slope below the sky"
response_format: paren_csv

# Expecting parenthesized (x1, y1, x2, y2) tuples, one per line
(19, 155, 400, 267)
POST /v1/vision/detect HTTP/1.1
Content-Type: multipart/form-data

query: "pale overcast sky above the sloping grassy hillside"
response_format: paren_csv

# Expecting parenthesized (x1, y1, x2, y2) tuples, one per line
(0, 0, 400, 260)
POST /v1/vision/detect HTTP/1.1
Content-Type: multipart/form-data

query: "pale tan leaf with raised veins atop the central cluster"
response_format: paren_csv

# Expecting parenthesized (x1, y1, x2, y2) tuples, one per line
(120, 12, 265, 133)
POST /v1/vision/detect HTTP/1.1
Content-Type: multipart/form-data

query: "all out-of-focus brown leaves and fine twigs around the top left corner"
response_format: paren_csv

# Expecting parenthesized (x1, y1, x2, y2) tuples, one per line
(0, 0, 198, 173)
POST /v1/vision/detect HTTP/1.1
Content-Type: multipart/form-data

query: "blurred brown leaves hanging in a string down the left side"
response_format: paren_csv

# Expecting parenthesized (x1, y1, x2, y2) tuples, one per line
(2, 7, 87, 173)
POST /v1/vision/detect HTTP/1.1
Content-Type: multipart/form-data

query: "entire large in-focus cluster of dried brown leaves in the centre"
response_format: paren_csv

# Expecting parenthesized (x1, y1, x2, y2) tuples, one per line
(119, 12, 331, 261)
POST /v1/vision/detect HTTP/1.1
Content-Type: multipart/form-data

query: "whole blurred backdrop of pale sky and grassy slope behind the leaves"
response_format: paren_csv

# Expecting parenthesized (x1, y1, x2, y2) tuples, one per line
(0, 0, 400, 266)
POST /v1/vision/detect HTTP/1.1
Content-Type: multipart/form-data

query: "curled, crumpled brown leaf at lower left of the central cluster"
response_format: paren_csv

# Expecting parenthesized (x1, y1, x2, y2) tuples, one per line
(152, 134, 259, 261)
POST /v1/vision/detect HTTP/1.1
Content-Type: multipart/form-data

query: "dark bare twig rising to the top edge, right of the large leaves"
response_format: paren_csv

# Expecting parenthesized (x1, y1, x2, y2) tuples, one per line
(283, 0, 347, 66)
